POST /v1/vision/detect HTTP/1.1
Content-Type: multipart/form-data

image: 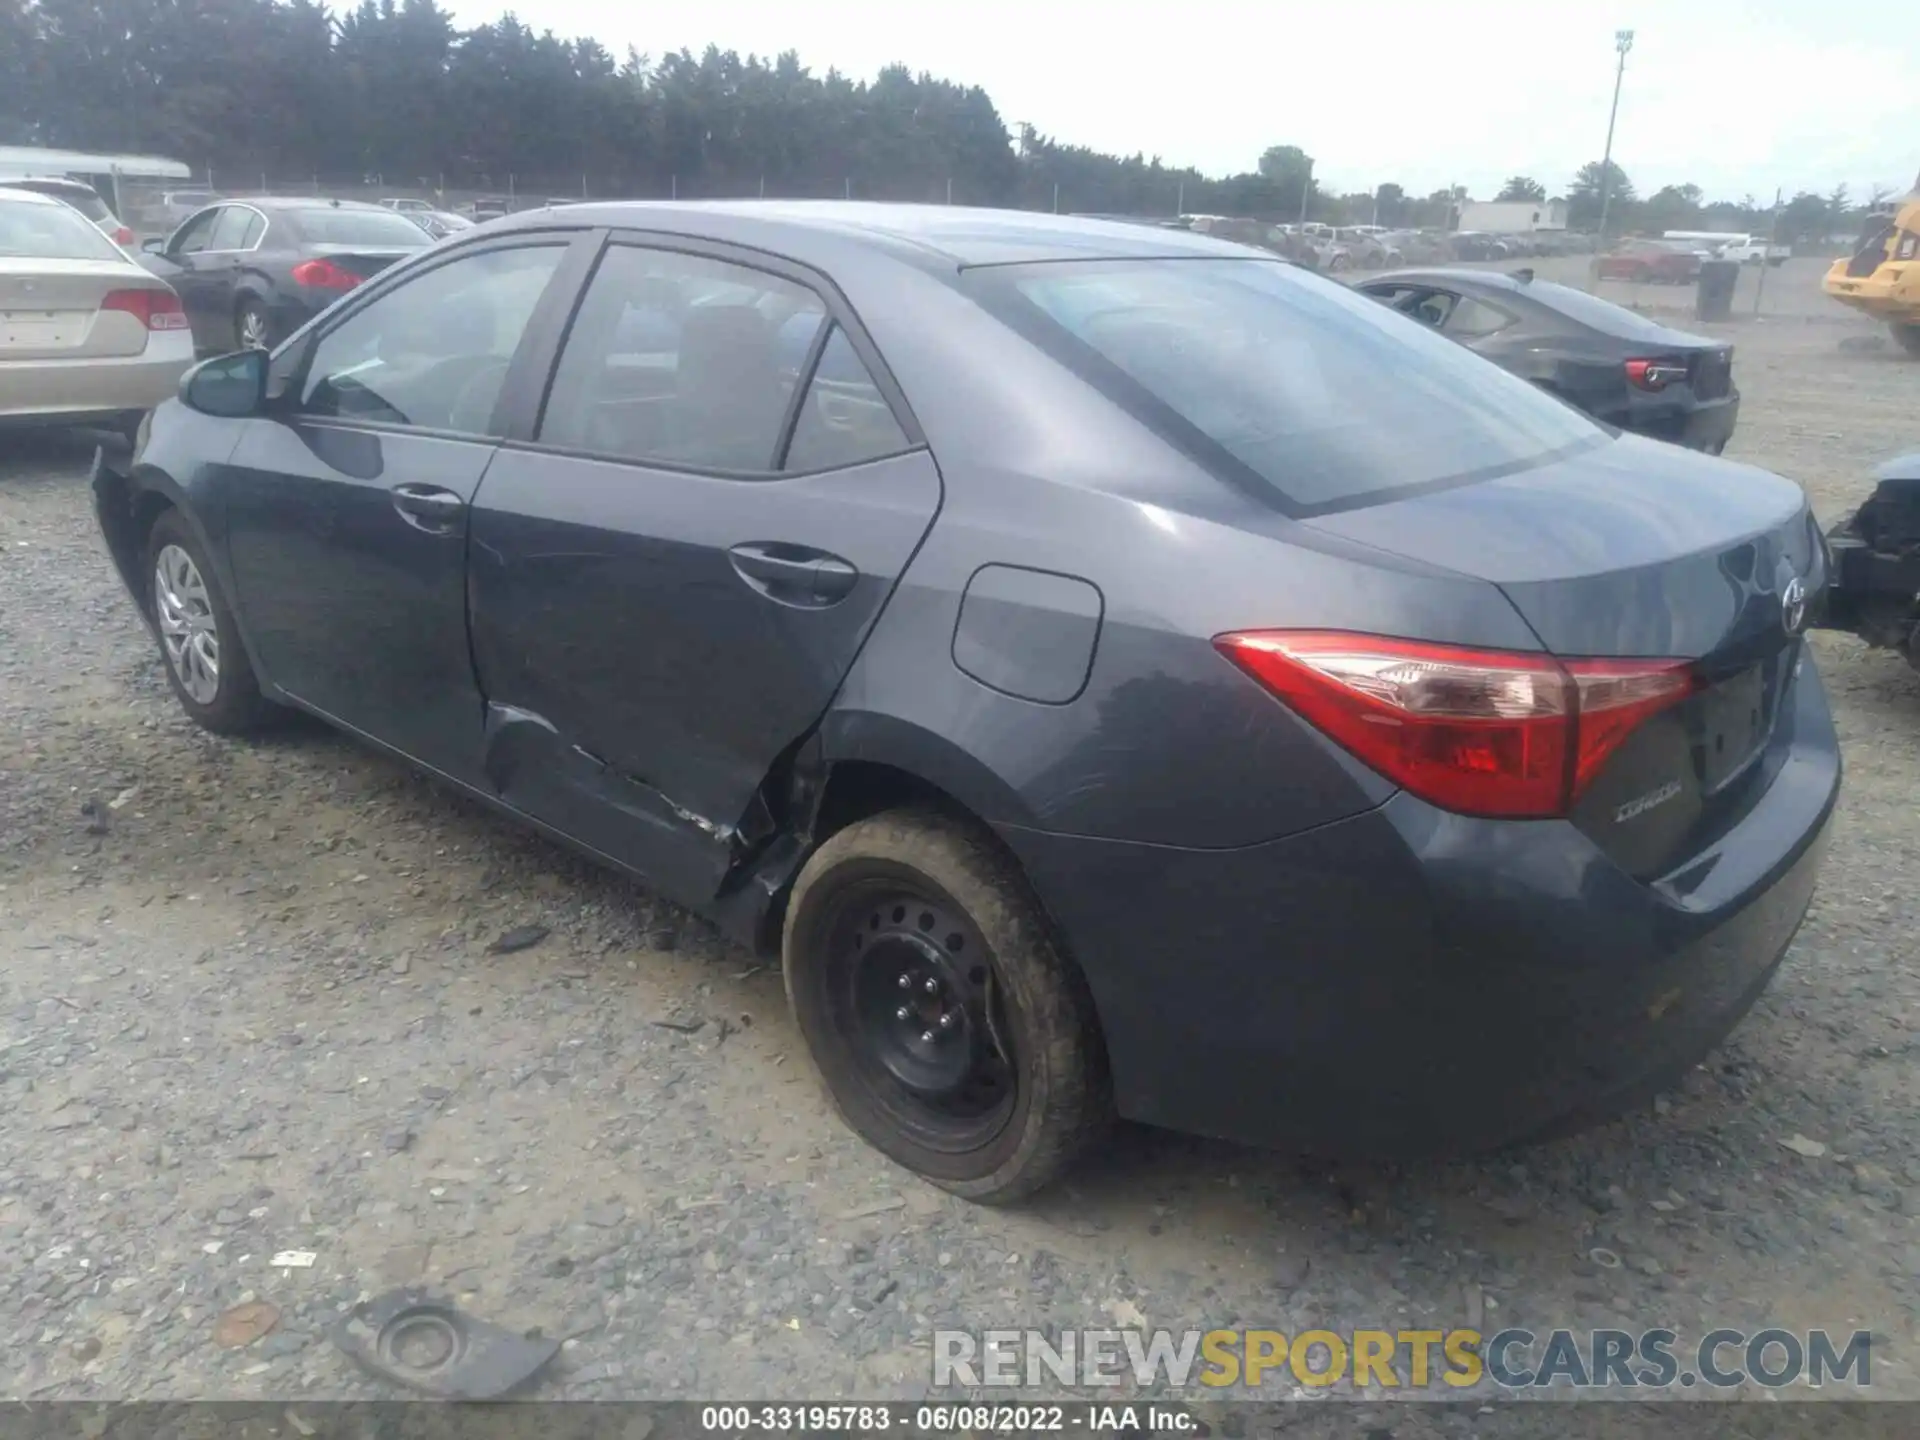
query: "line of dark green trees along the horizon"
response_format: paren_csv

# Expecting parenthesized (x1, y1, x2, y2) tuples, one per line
(0, 0, 1889, 236)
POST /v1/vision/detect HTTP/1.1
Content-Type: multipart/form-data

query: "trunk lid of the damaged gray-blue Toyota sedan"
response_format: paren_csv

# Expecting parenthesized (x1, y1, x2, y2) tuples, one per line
(1304, 436, 1826, 877)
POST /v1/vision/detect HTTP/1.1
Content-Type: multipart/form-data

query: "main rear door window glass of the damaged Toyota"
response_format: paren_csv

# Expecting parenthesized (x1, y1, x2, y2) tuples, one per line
(540, 246, 826, 472)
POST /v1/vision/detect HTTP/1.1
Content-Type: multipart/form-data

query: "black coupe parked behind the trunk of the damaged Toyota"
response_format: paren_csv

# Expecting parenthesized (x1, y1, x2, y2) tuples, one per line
(1359, 269, 1740, 455)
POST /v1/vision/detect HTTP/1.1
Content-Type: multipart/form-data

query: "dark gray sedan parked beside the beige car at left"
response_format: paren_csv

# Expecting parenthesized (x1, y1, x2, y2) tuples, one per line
(138, 196, 432, 353)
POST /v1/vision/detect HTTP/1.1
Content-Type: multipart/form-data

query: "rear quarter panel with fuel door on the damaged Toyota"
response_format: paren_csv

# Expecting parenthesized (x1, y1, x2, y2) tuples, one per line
(822, 272, 1540, 849)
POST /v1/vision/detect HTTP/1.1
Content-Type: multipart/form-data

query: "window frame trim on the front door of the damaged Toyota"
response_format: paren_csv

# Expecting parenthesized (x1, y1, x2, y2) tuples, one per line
(273, 227, 603, 445)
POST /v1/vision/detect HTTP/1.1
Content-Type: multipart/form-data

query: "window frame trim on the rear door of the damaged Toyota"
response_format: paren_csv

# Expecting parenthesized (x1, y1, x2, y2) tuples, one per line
(501, 227, 927, 482)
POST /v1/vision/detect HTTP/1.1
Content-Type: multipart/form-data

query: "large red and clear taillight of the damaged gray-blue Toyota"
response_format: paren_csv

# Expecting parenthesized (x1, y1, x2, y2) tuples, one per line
(1213, 630, 1695, 820)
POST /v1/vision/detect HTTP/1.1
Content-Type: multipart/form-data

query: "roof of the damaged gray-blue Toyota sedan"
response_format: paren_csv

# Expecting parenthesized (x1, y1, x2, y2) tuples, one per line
(488, 200, 1279, 267)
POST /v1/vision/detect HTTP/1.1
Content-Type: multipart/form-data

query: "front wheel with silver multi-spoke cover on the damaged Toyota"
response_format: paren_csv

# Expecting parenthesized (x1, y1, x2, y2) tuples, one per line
(146, 511, 276, 735)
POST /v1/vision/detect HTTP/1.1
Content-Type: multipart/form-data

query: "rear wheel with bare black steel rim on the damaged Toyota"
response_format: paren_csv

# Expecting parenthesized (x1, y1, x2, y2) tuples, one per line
(781, 810, 1112, 1204)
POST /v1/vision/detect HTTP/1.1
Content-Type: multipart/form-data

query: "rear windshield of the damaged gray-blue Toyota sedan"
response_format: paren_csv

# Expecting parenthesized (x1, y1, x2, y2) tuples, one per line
(968, 259, 1607, 513)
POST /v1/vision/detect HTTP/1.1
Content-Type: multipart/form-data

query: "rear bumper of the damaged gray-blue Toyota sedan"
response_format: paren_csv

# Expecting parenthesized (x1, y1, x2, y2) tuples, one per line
(1006, 662, 1839, 1158)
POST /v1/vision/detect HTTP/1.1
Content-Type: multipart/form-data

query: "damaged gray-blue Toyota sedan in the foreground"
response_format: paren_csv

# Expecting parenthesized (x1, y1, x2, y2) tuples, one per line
(94, 204, 1839, 1200)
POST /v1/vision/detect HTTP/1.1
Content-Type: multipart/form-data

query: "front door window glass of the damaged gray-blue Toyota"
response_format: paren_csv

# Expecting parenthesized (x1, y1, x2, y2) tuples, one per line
(300, 245, 566, 436)
